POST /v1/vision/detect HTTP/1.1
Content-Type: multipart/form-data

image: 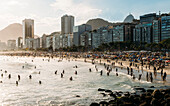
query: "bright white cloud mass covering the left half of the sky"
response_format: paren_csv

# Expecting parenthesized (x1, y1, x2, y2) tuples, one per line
(0, 0, 102, 36)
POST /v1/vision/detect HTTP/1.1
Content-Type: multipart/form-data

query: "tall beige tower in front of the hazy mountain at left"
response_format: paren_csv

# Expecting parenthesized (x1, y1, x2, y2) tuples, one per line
(22, 19, 34, 45)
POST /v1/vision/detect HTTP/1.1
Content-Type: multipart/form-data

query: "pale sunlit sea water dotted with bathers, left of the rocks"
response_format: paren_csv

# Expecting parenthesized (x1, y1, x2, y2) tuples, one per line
(0, 56, 169, 106)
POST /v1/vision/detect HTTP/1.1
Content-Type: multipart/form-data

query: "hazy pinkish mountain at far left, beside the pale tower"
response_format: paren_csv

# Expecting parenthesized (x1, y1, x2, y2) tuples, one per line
(0, 23, 22, 42)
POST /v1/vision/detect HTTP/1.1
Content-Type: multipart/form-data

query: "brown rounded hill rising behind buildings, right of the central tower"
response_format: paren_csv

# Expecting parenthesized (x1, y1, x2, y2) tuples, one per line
(86, 18, 112, 30)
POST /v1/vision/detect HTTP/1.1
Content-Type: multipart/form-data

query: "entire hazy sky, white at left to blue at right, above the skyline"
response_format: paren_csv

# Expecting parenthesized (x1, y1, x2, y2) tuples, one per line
(0, 0, 170, 36)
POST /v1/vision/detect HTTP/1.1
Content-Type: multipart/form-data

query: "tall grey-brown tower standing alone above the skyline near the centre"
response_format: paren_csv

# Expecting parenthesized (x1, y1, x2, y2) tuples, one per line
(61, 15, 74, 34)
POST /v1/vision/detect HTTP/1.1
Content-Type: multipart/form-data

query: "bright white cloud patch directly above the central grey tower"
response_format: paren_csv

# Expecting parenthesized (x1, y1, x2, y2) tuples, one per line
(50, 0, 102, 25)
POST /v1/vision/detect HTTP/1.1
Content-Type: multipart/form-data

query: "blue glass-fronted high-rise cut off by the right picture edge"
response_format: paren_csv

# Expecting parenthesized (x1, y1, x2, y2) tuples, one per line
(161, 16, 170, 40)
